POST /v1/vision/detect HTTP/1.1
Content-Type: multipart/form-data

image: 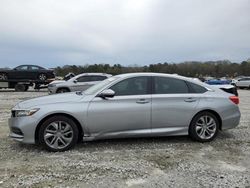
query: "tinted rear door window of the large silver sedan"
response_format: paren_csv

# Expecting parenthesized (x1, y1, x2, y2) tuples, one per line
(154, 77, 189, 94)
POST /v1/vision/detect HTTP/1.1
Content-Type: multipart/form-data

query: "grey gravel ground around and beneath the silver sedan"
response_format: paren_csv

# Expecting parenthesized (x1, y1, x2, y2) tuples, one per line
(0, 90, 250, 187)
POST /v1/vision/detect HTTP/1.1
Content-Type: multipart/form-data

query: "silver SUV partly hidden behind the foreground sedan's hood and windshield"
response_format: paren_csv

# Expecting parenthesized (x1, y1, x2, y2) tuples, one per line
(48, 73, 112, 94)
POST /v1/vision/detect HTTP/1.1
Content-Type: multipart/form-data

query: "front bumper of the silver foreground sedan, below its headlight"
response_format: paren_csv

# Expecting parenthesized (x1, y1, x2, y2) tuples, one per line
(9, 116, 37, 144)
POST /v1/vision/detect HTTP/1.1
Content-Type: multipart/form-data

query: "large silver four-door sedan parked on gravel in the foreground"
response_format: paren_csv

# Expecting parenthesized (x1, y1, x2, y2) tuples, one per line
(9, 73, 240, 151)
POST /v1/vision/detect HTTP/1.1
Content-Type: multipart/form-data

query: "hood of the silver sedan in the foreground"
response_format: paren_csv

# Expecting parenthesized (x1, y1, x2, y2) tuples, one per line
(15, 92, 84, 109)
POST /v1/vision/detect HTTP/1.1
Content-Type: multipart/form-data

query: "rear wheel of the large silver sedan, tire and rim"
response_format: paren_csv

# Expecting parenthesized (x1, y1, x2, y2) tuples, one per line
(189, 111, 219, 142)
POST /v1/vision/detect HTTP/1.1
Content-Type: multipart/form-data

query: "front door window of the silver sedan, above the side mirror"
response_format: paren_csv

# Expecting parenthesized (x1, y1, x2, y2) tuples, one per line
(110, 76, 149, 96)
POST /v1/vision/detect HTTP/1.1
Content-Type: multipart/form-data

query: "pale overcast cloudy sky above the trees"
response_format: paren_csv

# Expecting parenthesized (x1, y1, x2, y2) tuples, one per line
(0, 0, 250, 68)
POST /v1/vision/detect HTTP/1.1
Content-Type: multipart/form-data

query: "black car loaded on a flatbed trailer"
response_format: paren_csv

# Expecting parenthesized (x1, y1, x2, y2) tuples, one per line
(0, 65, 55, 81)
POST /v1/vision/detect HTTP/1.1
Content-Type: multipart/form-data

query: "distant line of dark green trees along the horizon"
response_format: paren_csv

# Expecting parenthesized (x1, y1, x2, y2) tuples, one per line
(54, 60, 250, 78)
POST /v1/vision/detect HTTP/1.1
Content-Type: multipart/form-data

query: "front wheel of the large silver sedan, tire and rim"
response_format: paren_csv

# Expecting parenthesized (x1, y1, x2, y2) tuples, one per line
(39, 116, 78, 152)
